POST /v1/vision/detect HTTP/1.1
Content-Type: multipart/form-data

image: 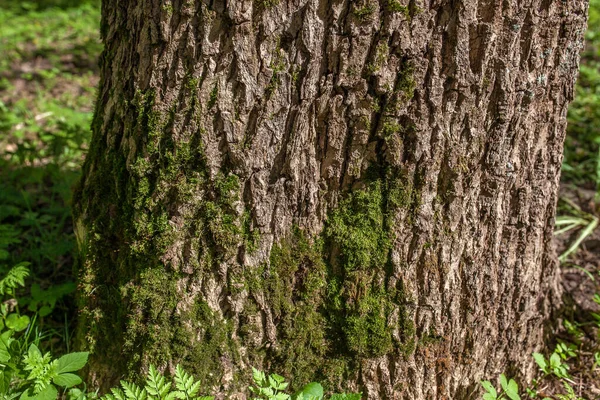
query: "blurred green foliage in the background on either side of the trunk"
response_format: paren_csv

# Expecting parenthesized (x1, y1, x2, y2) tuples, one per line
(0, 0, 600, 366)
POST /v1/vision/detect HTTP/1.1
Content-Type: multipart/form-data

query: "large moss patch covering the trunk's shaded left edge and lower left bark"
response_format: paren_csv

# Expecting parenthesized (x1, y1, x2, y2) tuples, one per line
(75, 86, 241, 382)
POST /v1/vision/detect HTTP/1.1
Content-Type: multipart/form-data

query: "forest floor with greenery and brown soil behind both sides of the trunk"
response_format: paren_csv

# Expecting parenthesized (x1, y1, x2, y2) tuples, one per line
(0, 0, 600, 399)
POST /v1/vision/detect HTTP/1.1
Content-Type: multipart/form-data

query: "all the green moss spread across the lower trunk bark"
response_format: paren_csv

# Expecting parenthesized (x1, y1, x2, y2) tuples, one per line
(79, 72, 418, 385)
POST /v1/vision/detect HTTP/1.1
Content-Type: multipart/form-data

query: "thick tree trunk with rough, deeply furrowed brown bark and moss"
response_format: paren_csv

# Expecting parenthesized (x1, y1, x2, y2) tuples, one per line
(75, 0, 587, 399)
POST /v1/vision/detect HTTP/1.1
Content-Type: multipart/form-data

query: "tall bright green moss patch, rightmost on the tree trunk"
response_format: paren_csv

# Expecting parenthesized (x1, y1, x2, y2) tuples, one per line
(325, 177, 414, 358)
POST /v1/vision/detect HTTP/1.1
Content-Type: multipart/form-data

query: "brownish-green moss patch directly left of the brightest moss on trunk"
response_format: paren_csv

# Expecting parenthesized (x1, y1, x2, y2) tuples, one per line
(245, 228, 331, 385)
